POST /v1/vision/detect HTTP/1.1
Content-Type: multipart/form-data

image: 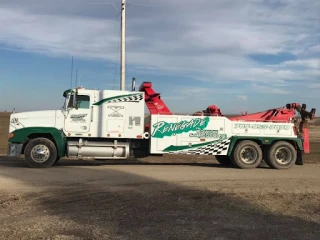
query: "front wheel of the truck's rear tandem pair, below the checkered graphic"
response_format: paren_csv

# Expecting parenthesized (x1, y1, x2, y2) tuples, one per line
(231, 140, 263, 169)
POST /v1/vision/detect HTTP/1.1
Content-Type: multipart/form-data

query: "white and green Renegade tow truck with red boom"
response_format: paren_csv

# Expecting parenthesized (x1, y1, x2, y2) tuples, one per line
(8, 82, 316, 169)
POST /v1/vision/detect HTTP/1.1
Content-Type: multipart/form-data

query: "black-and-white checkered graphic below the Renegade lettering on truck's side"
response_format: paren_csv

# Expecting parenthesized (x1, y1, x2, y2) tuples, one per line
(169, 138, 231, 155)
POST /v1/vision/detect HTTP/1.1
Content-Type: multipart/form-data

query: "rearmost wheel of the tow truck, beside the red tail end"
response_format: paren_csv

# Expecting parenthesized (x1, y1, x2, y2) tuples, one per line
(266, 141, 297, 169)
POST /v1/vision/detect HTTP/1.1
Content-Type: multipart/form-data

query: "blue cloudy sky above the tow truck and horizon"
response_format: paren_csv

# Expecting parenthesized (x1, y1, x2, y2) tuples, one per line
(0, 0, 320, 116)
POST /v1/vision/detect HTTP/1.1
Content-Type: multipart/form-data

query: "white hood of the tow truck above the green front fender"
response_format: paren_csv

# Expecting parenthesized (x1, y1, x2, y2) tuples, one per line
(9, 110, 64, 133)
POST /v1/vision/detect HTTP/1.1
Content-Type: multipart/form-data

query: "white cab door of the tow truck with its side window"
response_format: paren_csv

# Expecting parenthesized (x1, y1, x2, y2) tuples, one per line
(64, 94, 92, 133)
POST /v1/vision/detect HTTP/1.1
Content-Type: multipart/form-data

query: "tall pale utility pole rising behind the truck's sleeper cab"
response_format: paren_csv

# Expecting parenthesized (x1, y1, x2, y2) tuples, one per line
(120, 0, 126, 91)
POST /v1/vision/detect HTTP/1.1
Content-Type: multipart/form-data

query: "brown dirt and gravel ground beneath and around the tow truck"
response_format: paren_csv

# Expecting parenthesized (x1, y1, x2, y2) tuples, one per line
(0, 113, 320, 240)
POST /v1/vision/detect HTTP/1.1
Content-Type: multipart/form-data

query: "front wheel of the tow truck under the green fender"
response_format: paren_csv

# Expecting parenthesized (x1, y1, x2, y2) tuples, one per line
(24, 138, 57, 168)
